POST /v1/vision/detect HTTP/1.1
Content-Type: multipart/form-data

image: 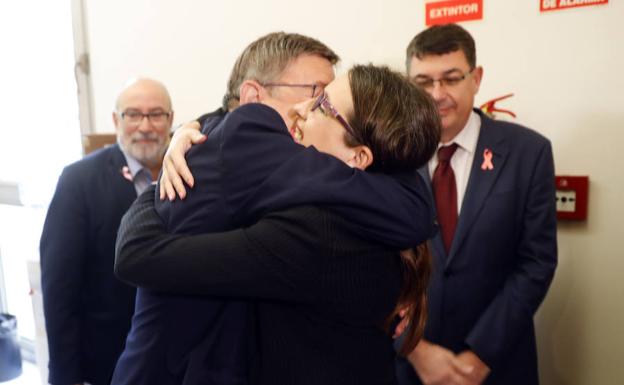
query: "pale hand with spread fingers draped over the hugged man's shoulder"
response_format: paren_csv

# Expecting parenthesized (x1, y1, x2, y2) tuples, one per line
(160, 121, 207, 201)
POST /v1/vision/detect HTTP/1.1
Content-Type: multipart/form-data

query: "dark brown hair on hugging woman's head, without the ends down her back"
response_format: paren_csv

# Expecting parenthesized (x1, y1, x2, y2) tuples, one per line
(345, 65, 440, 173)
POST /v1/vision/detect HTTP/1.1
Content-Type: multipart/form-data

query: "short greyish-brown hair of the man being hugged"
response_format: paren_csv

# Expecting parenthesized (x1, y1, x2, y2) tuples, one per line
(223, 32, 340, 110)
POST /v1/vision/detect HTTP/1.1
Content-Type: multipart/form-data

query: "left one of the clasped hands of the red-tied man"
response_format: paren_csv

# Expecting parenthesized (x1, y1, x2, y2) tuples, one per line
(407, 340, 474, 385)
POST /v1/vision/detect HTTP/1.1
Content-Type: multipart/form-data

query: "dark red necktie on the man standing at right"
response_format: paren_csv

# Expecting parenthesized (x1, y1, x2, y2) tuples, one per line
(431, 143, 457, 253)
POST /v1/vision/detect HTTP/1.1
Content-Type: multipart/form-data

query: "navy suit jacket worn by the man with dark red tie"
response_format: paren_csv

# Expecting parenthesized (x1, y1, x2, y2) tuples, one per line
(398, 109, 557, 385)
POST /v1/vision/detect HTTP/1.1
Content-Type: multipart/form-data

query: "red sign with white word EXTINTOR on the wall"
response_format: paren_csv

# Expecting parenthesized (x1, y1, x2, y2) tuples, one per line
(425, 0, 483, 26)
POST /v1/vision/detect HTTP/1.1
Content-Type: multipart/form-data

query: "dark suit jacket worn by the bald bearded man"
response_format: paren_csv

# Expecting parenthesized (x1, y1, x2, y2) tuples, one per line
(40, 145, 136, 385)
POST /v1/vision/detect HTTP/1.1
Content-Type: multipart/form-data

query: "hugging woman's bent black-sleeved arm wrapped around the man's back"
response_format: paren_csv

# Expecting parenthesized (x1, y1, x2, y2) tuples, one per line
(115, 187, 329, 302)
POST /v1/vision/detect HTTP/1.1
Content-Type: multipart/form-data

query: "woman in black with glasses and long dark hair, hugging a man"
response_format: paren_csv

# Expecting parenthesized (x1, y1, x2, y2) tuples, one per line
(115, 66, 439, 385)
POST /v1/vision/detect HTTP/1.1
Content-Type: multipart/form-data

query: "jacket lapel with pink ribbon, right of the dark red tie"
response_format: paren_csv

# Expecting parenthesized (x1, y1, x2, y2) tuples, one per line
(442, 113, 508, 268)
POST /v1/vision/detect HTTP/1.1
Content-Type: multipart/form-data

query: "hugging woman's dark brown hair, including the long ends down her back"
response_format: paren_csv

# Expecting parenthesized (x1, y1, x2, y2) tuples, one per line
(345, 65, 441, 355)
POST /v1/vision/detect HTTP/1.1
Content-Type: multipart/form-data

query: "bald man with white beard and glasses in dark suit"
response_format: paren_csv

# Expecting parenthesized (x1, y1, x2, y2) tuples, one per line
(40, 79, 173, 385)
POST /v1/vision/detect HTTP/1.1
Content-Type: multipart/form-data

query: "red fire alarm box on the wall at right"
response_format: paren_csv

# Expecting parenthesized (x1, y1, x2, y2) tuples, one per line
(555, 175, 589, 221)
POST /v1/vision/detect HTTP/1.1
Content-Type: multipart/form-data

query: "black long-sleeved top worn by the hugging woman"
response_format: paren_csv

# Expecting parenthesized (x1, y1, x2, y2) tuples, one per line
(115, 190, 401, 385)
